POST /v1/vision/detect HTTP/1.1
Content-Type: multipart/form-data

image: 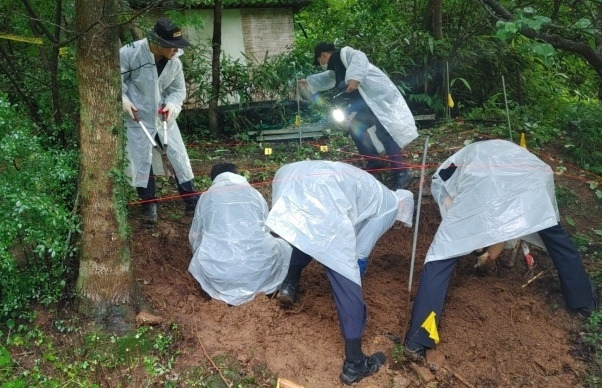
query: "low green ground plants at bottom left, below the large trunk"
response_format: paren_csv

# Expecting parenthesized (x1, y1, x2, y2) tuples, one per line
(0, 317, 179, 387)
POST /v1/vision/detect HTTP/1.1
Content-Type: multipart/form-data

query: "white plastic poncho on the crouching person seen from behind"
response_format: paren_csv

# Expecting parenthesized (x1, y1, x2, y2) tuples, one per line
(188, 172, 292, 306)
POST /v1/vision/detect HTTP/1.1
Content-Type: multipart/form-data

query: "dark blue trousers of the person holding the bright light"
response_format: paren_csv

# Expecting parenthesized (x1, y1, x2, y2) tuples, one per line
(349, 103, 404, 174)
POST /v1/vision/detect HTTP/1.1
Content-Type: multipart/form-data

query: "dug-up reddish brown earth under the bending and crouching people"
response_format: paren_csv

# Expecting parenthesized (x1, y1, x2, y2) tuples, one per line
(131, 130, 600, 388)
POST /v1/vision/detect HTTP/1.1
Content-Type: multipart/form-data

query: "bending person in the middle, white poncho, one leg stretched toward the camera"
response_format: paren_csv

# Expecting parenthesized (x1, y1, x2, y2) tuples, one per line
(266, 160, 414, 385)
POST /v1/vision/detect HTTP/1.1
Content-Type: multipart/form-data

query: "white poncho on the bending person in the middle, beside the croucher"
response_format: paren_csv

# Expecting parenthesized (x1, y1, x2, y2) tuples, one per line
(266, 160, 414, 285)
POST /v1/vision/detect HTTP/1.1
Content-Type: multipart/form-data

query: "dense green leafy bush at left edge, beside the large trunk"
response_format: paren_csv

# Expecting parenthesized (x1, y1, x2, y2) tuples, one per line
(0, 95, 78, 321)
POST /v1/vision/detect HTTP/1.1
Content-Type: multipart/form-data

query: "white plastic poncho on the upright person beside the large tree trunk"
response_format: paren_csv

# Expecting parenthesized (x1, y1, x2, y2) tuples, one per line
(119, 39, 194, 187)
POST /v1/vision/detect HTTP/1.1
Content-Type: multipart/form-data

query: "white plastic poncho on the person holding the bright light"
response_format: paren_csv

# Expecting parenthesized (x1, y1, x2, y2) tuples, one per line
(307, 47, 418, 148)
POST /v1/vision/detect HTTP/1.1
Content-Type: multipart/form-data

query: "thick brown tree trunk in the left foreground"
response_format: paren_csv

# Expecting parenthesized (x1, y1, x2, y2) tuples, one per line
(75, 0, 136, 332)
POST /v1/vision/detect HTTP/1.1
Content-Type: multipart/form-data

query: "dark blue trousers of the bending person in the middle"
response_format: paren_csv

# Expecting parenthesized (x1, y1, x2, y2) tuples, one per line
(285, 247, 366, 340)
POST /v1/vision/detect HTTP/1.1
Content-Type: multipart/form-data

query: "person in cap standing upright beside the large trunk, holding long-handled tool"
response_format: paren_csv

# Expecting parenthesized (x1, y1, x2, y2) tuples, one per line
(119, 19, 198, 224)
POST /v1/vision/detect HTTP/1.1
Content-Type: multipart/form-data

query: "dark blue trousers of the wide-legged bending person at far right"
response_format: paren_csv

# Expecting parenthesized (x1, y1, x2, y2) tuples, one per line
(405, 224, 594, 350)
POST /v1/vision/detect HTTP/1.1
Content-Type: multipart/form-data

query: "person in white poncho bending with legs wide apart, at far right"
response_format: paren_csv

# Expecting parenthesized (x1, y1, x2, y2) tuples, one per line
(404, 140, 599, 361)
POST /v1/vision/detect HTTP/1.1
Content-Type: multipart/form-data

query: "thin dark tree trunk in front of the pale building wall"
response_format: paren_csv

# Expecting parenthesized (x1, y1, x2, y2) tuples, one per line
(208, 0, 222, 137)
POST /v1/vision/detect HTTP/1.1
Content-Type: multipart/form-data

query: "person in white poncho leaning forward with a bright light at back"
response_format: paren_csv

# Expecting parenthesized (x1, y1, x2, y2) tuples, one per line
(299, 42, 418, 190)
